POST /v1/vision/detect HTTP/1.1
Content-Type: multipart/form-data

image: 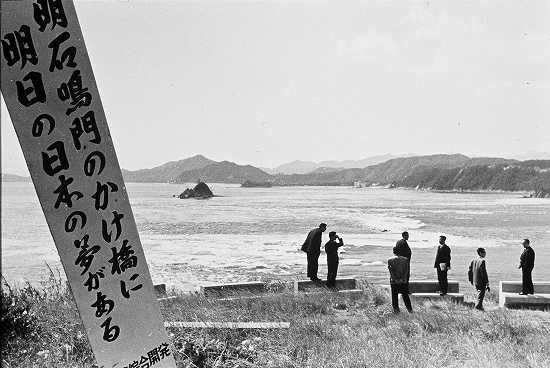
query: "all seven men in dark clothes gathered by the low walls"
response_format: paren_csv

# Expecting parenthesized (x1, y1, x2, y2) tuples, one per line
(302, 223, 535, 313)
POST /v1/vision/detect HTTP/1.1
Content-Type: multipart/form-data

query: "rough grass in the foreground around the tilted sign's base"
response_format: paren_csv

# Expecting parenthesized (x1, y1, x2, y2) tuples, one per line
(1, 272, 550, 368)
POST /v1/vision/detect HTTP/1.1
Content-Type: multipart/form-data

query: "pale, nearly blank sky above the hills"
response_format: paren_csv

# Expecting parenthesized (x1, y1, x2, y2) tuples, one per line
(1, 0, 550, 175)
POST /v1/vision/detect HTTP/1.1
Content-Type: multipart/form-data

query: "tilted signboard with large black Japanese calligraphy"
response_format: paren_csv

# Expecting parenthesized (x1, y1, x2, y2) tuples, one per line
(0, 0, 175, 368)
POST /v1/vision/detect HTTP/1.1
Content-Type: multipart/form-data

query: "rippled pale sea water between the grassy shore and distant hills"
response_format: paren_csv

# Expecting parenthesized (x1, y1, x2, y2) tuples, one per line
(2, 183, 550, 290)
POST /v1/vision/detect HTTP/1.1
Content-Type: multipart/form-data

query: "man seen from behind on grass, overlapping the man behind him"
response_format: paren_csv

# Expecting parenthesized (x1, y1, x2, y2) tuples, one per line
(388, 247, 412, 313)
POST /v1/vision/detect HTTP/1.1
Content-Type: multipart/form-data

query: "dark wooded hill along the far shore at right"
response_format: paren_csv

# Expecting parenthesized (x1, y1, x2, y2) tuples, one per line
(274, 155, 550, 191)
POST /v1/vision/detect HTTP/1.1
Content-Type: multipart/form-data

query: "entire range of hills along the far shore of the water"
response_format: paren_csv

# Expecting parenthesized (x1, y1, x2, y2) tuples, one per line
(116, 154, 550, 191)
